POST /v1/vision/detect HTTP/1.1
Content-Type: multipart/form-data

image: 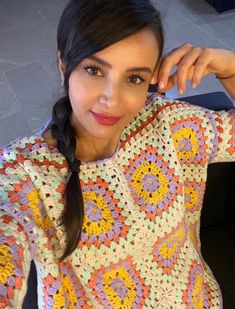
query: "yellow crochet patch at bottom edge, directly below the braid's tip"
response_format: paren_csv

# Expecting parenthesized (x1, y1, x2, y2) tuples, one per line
(53, 276, 77, 309)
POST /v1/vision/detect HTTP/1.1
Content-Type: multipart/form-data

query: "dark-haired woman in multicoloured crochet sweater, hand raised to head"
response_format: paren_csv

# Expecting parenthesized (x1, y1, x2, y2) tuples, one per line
(0, 0, 235, 309)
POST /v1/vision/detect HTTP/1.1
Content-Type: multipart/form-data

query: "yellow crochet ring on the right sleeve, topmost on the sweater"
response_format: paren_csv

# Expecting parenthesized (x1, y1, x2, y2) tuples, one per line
(172, 128, 198, 159)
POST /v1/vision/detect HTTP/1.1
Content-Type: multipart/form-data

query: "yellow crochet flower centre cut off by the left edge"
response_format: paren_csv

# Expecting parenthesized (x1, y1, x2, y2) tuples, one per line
(0, 243, 15, 284)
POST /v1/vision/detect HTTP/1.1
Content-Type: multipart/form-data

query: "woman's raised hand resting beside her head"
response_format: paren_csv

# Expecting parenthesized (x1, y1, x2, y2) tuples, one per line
(156, 44, 235, 94)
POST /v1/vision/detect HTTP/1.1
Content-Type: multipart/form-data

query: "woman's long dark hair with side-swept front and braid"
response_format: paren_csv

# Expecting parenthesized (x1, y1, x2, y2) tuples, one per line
(51, 0, 163, 260)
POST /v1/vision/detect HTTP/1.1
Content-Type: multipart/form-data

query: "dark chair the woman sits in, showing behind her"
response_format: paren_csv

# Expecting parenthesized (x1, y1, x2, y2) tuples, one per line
(22, 90, 235, 309)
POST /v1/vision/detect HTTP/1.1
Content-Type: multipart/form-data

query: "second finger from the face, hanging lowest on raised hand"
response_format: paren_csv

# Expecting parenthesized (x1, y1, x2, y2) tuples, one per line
(177, 47, 202, 94)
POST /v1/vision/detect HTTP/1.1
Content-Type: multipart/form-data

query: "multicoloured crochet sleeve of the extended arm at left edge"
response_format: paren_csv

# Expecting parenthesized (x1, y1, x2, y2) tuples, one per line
(0, 148, 37, 308)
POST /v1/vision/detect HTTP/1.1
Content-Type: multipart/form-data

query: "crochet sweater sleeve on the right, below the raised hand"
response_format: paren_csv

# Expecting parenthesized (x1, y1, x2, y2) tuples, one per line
(164, 101, 235, 165)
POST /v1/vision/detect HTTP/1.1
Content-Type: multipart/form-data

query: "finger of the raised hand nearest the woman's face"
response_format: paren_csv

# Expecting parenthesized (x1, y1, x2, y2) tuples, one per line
(157, 44, 192, 90)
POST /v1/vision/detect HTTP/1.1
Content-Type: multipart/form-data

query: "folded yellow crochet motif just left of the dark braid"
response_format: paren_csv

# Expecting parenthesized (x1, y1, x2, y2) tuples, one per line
(27, 189, 52, 231)
